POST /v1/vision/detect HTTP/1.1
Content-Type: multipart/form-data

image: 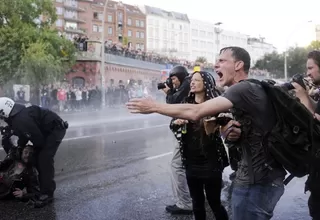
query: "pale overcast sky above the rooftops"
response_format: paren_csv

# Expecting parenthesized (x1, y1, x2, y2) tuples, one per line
(123, 0, 320, 51)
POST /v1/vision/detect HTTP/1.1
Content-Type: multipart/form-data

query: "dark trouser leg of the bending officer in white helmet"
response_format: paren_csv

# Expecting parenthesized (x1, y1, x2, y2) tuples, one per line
(36, 129, 66, 196)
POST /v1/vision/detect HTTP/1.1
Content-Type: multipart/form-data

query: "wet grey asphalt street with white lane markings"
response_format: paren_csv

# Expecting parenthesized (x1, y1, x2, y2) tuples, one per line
(0, 110, 310, 220)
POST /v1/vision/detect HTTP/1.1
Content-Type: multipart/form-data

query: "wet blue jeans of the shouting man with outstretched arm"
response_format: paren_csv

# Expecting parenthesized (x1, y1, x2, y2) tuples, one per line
(231, 183, 284, 220)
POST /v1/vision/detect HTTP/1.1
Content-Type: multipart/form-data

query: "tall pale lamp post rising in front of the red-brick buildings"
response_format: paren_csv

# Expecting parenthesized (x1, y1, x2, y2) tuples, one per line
(100, 0, 109, 107)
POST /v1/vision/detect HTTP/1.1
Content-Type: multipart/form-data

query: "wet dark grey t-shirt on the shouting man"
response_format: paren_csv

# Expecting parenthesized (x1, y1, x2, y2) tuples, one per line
(222, 81, 286, 184)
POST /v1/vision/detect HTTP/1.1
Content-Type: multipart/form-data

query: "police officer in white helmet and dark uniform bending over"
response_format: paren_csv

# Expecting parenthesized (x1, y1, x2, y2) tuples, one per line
(0, 97, 68, 207)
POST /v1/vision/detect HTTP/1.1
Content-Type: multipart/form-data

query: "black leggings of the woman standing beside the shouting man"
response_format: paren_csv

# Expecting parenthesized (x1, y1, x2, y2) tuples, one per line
(187, 172, 229, 220)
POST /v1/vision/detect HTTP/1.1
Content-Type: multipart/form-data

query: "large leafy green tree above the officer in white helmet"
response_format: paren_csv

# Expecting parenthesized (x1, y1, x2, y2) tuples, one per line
(0, 0, 75, 85)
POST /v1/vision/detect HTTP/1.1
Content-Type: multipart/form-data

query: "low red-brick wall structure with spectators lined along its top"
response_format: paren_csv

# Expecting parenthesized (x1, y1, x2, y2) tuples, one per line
(66, 41, 166, 86)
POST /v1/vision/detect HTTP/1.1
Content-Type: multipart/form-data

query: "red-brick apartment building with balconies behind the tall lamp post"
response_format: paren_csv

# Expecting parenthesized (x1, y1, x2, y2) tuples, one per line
(55, 0, 146, 51)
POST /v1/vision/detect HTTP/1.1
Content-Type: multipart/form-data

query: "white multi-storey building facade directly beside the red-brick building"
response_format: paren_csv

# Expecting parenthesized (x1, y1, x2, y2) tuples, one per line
(140, 6, 190, 60)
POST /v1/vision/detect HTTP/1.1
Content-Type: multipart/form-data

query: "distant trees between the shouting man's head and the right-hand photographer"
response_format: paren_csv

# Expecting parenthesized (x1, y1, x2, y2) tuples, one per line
(255, 41, 320, 78)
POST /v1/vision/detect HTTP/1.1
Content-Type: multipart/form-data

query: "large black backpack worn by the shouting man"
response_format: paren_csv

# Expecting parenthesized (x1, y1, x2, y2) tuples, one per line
(242, 79, 320, 185)
